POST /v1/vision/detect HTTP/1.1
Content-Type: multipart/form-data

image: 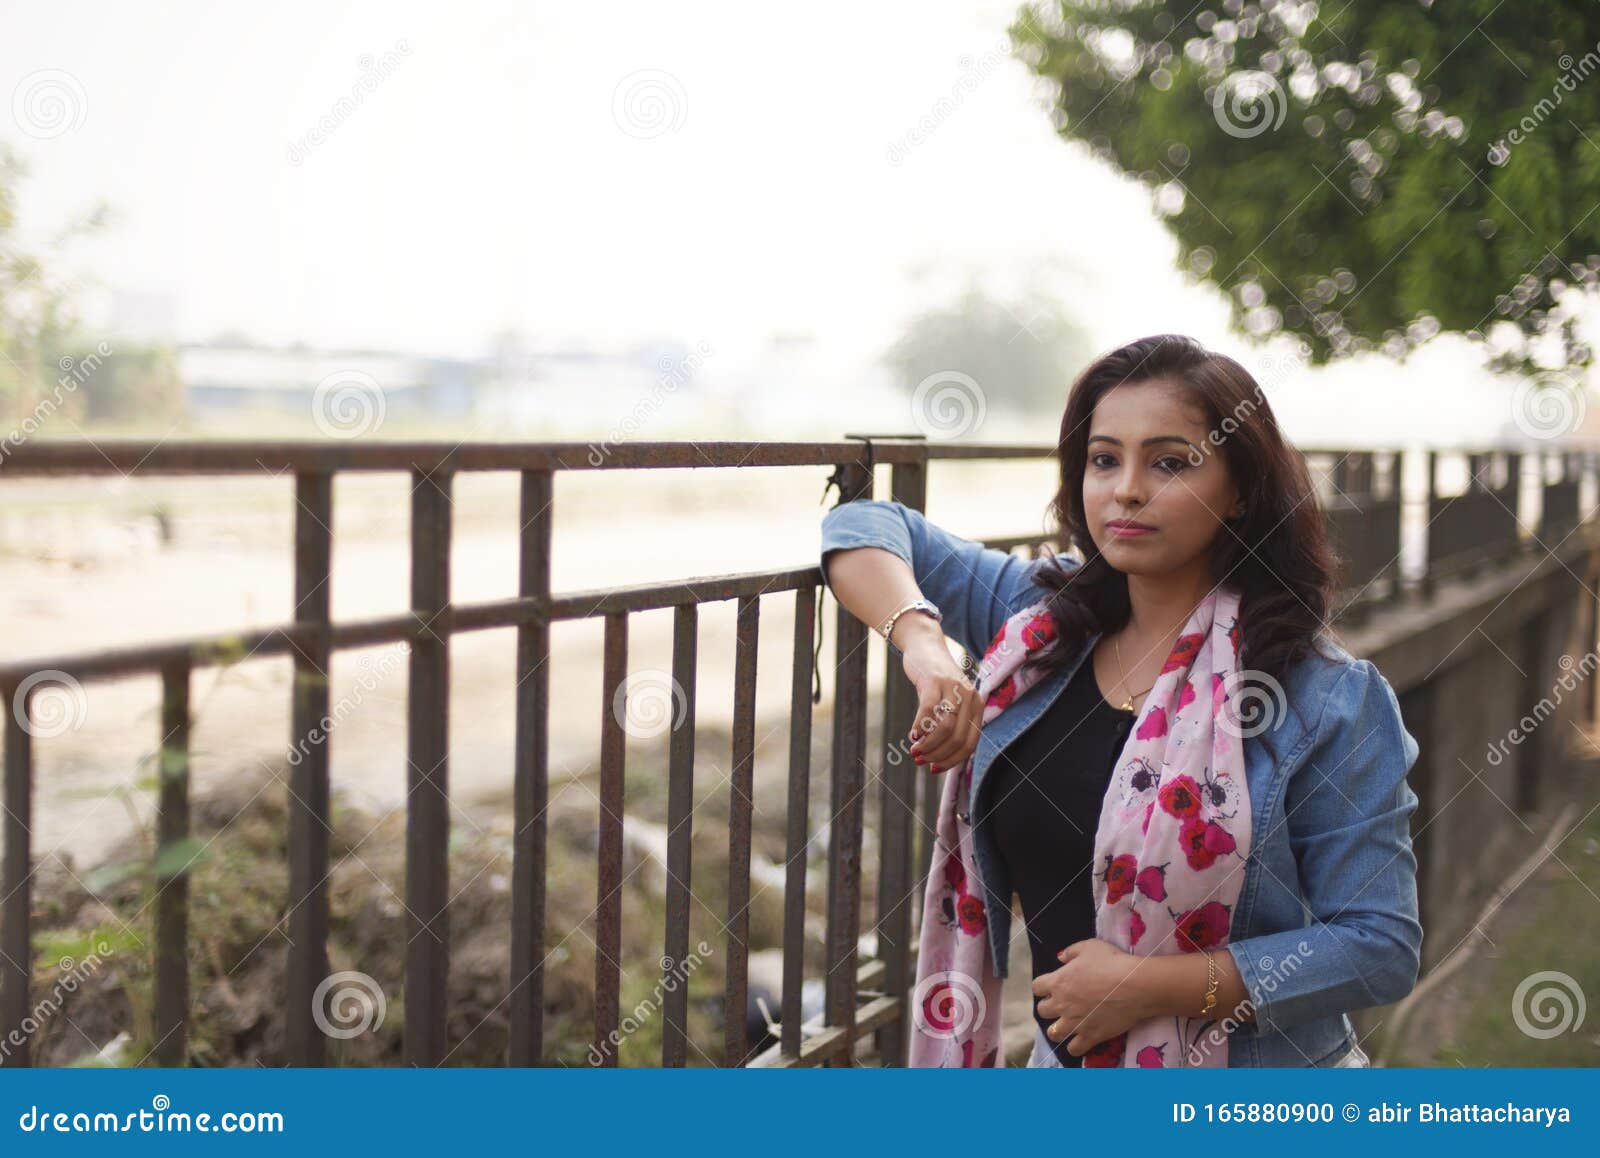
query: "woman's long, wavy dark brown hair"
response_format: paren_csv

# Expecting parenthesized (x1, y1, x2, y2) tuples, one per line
(1029, 334, 1342, 683)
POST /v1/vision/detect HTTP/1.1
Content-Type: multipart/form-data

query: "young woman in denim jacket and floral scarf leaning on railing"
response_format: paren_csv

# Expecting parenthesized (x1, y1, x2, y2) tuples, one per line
(821, 336, 1422, 1067)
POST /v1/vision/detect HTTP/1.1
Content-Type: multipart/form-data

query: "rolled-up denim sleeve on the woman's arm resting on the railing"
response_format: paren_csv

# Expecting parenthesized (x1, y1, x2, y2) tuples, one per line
(821, 499, 1067, 659)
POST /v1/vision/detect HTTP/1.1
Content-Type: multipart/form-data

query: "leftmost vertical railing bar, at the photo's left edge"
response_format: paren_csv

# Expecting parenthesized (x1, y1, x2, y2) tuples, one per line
(0, 685, 34, 1067)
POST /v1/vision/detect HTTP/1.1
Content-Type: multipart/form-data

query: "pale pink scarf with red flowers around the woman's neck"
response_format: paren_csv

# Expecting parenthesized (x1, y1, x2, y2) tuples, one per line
(910, 585, 1250, 1067)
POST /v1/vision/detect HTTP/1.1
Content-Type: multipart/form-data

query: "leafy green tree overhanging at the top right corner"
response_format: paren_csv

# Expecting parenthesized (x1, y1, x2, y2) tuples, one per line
(1011, 0, 1600, 368)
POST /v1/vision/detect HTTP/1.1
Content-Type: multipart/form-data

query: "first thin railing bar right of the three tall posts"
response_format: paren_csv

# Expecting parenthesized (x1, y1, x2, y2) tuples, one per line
(595, 611, 627, 1068)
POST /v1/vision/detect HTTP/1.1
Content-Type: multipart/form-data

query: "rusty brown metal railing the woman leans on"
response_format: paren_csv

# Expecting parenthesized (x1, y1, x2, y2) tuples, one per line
(0, 435, 1587, 1065)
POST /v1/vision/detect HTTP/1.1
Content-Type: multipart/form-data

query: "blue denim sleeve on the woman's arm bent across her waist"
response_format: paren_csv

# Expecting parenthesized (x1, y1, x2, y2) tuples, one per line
(1227, 659, 1422, 1030)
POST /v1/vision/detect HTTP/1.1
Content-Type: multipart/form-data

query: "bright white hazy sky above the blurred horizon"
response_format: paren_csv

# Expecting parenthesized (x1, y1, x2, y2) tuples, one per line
(0, 0, 1574, 444)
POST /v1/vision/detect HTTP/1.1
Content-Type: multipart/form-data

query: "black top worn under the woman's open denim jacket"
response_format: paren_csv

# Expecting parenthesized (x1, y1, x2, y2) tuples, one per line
(986, 656, 1138, 1065)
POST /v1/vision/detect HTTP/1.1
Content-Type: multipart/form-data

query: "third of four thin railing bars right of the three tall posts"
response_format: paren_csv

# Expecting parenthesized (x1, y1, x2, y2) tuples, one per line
(722, 595, 762, 1065)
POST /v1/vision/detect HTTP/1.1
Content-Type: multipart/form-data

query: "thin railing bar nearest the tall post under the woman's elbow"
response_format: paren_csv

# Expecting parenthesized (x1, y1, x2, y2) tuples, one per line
(781, 587, 816, 1057)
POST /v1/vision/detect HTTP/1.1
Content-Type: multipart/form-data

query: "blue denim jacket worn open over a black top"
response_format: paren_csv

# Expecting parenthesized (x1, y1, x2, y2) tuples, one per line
(821, 499, 1422, 1067)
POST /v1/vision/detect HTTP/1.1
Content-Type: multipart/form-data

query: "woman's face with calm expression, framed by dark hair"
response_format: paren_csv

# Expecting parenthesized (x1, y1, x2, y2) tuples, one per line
(1083, 379, 1242, 574)
